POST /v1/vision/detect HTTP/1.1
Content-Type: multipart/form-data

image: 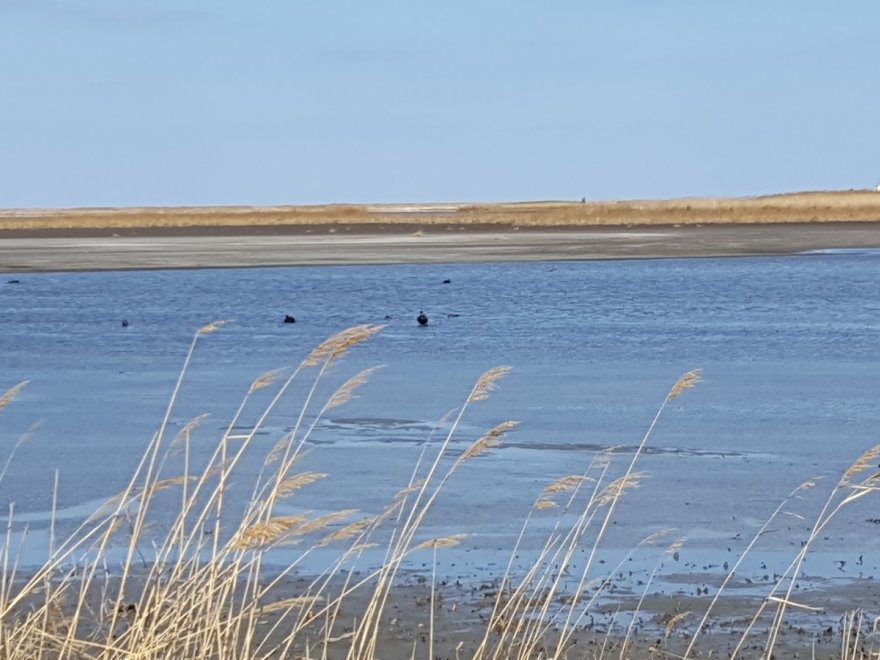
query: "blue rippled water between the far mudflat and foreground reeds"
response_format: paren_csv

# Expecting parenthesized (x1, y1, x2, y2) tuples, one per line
(0, 251, 880, 576)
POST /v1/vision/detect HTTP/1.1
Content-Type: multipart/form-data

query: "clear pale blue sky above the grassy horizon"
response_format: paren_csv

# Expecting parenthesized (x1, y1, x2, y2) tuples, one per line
(0, 0, 880, 208)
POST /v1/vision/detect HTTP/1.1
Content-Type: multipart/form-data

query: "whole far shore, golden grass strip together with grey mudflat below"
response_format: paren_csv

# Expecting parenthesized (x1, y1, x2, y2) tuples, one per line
(0, 191, 880, 273)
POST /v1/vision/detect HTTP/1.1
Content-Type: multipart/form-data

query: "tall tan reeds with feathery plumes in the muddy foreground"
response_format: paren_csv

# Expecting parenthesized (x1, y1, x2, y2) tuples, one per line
(0, 324, 878, 660)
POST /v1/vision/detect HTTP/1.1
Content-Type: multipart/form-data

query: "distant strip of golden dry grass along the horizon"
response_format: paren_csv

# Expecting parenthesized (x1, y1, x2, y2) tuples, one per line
(0, 190, 880, 231)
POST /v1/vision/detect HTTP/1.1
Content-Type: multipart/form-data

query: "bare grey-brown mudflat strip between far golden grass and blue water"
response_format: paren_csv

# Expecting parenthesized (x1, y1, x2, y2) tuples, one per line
(0, 222, 880, 273)
